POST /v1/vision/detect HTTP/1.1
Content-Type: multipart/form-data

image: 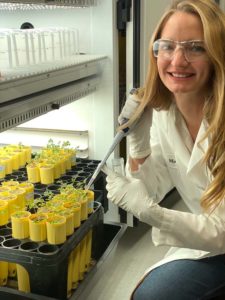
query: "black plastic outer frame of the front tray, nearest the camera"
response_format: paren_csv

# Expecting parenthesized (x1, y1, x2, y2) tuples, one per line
(0, 202, 103, 300)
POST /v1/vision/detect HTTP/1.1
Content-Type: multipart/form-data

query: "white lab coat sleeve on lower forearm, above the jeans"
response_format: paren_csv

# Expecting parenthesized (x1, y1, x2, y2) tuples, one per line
(147, 200, 225, 255)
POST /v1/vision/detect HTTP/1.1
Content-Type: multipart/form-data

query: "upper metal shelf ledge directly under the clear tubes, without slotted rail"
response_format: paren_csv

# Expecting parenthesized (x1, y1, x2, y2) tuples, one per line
(0, 55, 106, 104)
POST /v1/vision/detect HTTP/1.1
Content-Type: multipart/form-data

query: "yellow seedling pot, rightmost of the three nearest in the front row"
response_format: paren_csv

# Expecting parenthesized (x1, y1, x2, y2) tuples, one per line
(46, 215, 66, 245)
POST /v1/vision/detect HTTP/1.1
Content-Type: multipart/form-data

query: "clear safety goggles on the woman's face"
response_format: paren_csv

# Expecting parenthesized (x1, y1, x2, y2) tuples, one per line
(153, 39, 207, 62)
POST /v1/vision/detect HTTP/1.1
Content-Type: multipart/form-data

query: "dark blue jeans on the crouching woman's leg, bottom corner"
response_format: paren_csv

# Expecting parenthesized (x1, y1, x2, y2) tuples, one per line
(132, 255, 225, 300)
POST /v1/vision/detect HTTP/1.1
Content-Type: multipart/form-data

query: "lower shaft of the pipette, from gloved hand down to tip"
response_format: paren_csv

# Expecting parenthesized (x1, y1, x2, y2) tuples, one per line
(85, 128, 129, 190)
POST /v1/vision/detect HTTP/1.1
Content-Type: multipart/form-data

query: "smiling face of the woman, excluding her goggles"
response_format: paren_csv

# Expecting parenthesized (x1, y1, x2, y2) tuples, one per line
(157, 12, 212, 99)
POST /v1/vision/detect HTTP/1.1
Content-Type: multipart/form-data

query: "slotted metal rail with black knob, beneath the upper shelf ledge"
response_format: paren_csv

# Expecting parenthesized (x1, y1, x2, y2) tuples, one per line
(0, 75, 100, 132)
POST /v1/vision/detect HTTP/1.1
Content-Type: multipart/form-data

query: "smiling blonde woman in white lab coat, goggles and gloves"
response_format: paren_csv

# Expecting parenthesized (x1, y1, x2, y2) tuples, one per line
(104, 0, 225, 300)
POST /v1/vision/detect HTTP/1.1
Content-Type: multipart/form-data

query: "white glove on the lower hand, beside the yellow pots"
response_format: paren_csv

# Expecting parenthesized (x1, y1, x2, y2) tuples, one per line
(102, 166, 163, 227)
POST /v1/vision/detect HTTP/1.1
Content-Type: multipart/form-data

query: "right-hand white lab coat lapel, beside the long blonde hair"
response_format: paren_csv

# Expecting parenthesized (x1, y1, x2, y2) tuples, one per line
(187, 120, 208, 174)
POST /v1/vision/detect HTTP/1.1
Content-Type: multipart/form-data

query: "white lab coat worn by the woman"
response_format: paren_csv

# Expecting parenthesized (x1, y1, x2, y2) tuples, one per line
(127, 105, 225, 273)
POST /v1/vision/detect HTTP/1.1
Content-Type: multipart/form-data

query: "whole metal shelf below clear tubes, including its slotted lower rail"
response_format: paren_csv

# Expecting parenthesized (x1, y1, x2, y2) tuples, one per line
(0, 55, 106, 132)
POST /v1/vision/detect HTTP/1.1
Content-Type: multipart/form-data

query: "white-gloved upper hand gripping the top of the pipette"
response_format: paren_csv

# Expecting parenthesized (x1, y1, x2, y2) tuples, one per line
(118, 90, 152, 159)
